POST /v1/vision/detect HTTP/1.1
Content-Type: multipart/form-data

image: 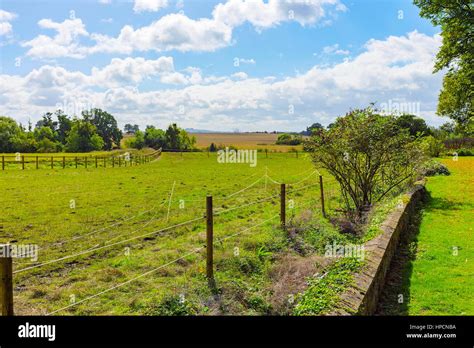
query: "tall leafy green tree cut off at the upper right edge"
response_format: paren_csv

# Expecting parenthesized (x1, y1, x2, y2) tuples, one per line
(414, 0, 474, 134)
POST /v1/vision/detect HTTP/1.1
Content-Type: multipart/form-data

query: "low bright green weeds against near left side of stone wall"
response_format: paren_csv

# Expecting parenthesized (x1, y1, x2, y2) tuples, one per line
(293, 258, 363, 315)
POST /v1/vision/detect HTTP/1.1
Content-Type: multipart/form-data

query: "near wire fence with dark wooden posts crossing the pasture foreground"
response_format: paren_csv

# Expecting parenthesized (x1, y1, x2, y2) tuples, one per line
(0, 163, 336, 315)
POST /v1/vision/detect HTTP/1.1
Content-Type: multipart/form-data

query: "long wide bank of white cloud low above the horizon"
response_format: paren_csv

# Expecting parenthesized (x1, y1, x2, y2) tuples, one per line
(0, 31, 443, 130)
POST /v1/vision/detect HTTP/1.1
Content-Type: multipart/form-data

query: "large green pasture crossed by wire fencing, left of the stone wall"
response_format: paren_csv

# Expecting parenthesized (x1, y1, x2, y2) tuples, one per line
(0, 153, 346, 315)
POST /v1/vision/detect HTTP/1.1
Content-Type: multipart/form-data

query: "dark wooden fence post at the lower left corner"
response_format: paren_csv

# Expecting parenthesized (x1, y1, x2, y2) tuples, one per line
(0, 244, 13, 316)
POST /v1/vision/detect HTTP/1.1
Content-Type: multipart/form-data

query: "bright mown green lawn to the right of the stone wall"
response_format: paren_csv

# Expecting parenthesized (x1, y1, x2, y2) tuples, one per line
(380, 157, 474, 315)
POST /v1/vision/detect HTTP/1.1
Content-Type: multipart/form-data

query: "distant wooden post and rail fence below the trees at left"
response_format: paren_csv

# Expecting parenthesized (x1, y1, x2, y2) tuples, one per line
(1, 149, 162, 170)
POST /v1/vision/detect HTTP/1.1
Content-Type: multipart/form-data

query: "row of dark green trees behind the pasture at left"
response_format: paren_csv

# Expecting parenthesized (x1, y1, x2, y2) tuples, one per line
(0, 108, 196, 153)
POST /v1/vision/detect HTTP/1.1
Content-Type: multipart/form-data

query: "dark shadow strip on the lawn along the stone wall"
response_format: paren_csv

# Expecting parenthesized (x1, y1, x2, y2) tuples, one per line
(375, 193, 428, 315)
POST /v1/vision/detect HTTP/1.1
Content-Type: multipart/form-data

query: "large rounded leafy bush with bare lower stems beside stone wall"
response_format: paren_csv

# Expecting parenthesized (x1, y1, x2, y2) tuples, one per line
(305, 107, 425, 218)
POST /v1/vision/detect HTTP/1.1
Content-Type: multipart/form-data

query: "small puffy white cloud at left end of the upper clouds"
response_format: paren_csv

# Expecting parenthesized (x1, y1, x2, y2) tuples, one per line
(21, 18, 89, 58)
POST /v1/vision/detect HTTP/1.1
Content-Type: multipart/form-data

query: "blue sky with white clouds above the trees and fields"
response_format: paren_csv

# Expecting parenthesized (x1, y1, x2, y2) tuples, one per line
(0, 0, 447, 131)
